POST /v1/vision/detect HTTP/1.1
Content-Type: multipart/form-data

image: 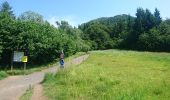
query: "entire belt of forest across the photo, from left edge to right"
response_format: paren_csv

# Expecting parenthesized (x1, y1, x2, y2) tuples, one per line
(0, 2, 170, 69)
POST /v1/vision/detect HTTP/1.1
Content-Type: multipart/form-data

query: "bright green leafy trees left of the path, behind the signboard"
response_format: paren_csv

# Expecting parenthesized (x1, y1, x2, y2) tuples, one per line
(0, 2, 89, 69)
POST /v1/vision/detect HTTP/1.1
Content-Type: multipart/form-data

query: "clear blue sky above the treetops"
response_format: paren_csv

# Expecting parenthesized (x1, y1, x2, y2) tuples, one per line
(0, 0, 170, 26)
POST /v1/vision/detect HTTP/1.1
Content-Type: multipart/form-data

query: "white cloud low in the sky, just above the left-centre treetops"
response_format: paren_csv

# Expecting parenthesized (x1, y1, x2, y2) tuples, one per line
(47, 15, 78, 27)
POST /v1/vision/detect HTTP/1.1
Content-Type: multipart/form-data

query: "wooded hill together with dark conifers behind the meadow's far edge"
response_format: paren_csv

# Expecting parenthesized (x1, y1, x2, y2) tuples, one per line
(79, 8, 170, 52)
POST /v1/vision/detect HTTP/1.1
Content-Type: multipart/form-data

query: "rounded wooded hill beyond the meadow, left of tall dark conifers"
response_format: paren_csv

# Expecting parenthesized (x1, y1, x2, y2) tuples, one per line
(79, 14, 135, 49)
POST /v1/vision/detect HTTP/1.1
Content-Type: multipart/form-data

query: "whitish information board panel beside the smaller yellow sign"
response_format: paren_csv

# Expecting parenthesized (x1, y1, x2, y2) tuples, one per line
(13, 51, 24, 62)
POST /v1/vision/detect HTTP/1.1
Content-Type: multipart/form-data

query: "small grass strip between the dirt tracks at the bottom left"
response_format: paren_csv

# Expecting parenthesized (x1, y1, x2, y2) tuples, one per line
(20, 87, 33, 100)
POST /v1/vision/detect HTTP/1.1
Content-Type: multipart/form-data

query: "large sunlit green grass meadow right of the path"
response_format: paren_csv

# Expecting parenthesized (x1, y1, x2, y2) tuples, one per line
(43, 50, 170, 100)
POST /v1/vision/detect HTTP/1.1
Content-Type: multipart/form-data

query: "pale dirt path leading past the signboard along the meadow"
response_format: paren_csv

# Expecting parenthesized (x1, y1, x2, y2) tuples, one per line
(0, 55, 89, 100)
